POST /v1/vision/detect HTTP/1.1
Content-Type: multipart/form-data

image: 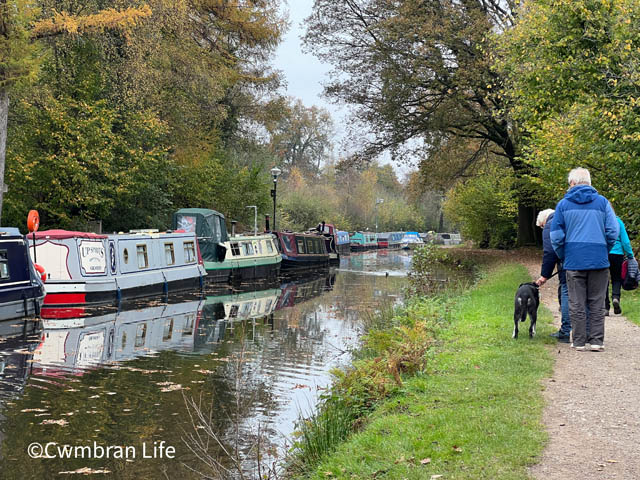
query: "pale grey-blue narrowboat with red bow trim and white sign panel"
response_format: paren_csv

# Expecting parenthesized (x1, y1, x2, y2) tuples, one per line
(29, 230, 206, 305)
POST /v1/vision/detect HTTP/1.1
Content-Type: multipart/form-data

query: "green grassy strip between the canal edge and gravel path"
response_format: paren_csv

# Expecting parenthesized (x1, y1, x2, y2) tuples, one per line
(292, 264, 552, 479)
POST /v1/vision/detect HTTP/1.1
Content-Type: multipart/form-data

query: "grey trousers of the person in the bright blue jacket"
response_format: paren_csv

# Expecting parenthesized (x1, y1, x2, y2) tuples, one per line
(567, 268, 609, 347)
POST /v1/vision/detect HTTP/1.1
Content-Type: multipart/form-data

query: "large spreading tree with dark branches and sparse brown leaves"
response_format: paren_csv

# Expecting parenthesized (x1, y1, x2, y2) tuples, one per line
(304, 0, 534, 243)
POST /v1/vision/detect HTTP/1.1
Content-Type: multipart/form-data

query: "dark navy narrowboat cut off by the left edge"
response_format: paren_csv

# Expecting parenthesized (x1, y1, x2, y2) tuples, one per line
(0, 227, 45, 321)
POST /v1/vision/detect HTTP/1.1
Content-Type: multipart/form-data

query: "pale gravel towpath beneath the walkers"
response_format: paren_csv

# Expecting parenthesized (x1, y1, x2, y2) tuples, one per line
(525, 258, 640, 480)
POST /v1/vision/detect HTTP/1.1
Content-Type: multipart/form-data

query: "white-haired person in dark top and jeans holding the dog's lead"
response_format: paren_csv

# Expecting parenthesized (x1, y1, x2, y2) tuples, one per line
(536, 208, 571, 343)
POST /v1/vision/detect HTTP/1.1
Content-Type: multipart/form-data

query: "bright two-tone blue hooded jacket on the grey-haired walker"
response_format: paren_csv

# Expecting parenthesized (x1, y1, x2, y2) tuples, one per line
(550, 185, 620, 270)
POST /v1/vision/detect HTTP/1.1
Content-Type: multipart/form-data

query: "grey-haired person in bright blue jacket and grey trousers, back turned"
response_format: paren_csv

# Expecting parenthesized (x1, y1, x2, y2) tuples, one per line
(550, 168, 619, 352)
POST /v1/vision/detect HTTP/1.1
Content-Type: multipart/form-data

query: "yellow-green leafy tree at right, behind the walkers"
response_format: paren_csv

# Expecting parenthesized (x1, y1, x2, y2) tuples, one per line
(499, 0, 640, 231)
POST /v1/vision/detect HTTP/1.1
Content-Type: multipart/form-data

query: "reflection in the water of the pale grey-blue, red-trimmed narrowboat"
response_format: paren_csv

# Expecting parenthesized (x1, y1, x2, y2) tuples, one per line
(34, 299, 204, 375)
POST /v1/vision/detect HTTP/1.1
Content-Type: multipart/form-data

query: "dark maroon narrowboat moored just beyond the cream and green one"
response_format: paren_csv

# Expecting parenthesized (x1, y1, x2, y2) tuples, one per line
(276, 232, 329, 270)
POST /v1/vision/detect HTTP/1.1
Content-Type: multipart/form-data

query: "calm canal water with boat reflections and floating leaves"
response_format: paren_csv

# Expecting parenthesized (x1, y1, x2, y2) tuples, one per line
(0, 251, 460, 480)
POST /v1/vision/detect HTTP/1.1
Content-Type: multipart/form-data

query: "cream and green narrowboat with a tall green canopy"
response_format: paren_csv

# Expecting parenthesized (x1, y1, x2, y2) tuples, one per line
(173, 208, 282, 283)
